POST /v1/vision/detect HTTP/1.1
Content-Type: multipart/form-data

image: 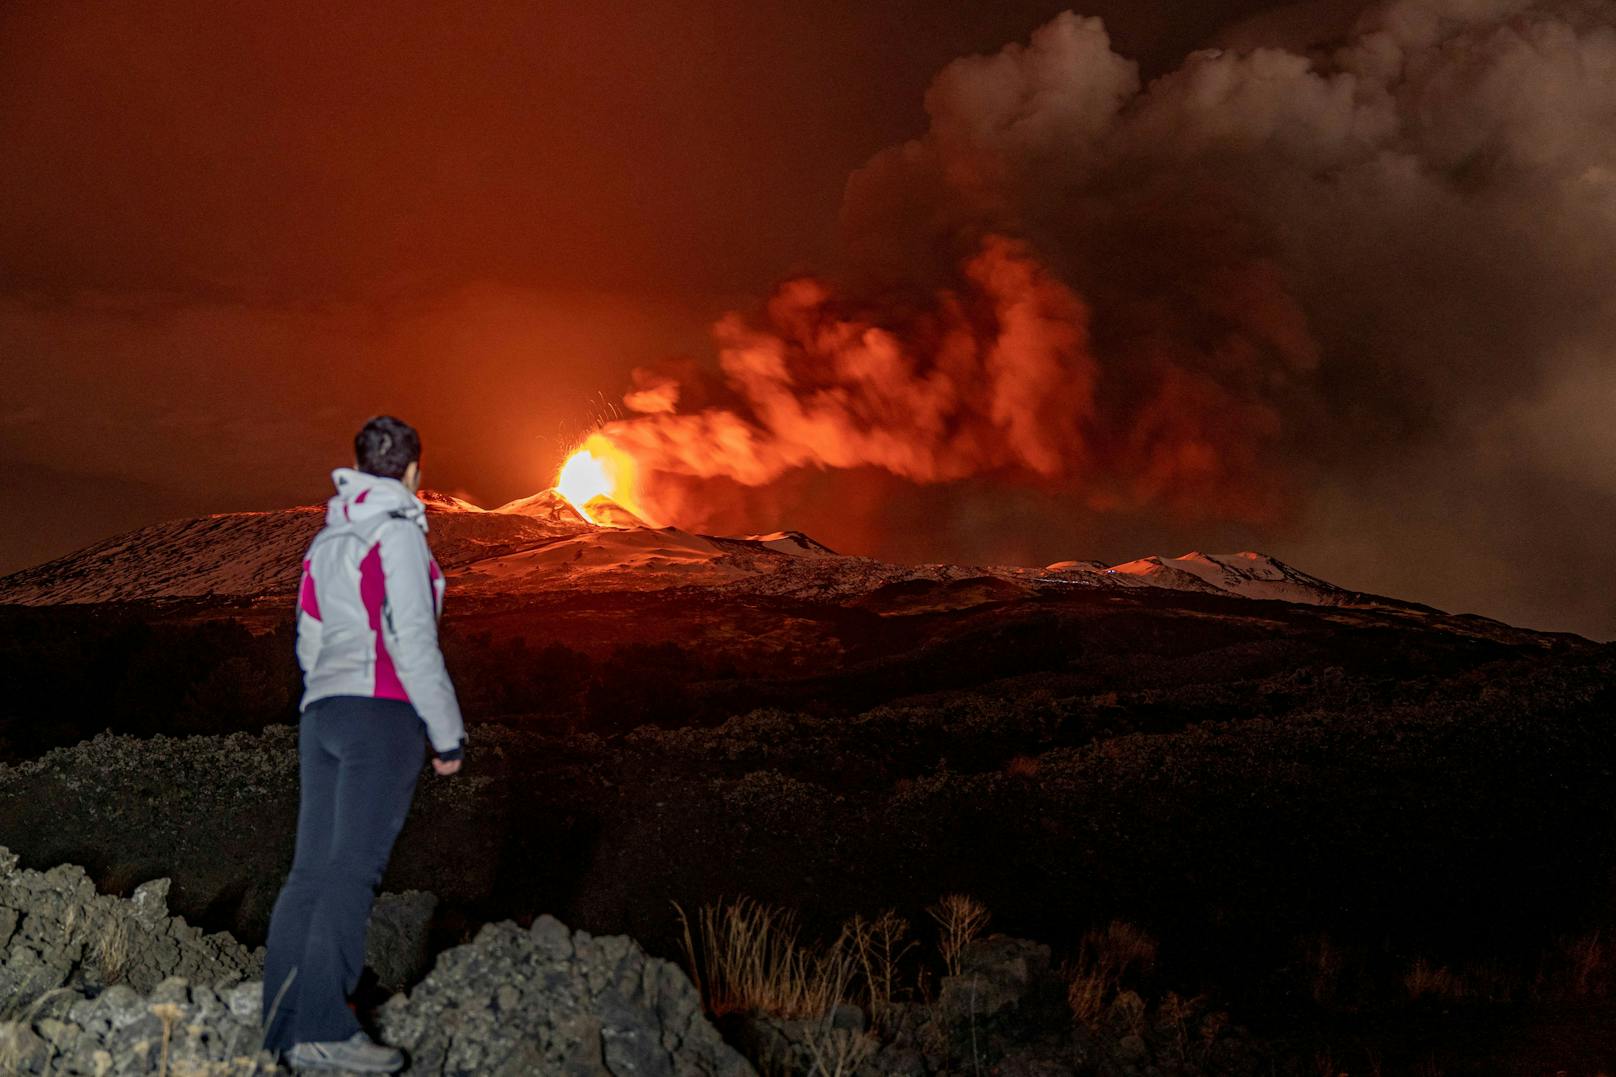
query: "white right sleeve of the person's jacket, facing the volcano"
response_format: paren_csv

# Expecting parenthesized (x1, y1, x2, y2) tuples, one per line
(380, 521, 465, 755)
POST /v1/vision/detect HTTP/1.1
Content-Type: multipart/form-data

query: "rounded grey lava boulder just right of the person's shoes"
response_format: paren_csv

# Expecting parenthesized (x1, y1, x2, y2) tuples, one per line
(378, 917, 755, 1077)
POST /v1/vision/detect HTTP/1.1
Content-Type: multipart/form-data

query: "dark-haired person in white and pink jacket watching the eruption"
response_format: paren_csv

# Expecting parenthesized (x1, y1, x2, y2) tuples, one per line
(263, 416, 465, 1074)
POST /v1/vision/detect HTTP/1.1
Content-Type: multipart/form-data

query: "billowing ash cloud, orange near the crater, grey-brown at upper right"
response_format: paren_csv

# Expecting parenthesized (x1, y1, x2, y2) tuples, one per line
(603, 0, 1616, 636)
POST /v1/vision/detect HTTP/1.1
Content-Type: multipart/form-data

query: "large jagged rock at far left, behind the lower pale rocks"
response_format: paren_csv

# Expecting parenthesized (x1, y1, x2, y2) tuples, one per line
(0, 849, 263, 1017)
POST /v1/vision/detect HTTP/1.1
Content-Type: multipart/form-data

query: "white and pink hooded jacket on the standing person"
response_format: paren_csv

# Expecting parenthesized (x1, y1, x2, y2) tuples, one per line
(297, 467, 465, 757)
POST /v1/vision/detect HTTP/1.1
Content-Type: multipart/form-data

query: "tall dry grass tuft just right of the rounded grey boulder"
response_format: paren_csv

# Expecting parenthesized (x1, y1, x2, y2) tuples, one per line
(674, 898, 856, 1019)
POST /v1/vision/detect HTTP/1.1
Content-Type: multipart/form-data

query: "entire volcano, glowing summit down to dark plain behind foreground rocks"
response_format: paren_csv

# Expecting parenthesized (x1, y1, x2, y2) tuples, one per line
(0, 490, 1616, 1073)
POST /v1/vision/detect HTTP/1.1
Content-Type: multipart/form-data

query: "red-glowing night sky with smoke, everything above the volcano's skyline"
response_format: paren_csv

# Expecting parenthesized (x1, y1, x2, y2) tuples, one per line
(0, 0, 1616, 637)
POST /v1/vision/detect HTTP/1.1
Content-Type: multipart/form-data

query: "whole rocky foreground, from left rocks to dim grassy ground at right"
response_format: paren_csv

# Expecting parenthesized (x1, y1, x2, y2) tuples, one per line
(0, 849, 1275, 1077)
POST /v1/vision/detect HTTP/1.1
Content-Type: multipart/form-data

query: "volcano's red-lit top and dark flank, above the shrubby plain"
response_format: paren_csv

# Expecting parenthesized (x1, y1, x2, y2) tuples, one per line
(0, 481, 1589, 760)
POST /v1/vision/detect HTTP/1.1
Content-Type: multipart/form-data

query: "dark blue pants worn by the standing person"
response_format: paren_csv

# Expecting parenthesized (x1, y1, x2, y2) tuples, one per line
(263, 695, 427, 1054)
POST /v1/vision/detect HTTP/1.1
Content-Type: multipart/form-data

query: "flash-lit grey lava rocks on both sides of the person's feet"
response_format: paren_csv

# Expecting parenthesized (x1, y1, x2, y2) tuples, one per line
(0, 851, 755, 1077)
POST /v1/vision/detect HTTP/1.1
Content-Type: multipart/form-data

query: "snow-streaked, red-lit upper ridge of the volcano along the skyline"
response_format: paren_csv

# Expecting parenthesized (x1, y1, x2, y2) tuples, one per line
(0, 490, 1416, 610)
